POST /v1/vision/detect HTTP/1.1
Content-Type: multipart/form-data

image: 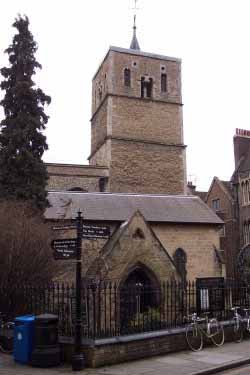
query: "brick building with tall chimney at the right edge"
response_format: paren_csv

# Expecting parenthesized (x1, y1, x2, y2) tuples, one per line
(205, 129, 250, 281)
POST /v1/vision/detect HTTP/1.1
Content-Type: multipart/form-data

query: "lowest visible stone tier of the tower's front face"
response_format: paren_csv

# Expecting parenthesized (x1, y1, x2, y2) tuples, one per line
(109, 140, 185, 194)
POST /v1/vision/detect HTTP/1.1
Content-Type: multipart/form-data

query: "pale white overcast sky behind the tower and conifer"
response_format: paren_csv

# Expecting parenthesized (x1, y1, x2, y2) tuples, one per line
(0, 0, 250, 190)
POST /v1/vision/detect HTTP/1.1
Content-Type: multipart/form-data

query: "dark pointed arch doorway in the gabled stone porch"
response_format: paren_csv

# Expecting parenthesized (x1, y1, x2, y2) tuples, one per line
(120, 264, 161, 331)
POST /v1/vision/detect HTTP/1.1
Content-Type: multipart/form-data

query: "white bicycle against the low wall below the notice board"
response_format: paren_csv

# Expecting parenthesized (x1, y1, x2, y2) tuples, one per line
(186, 312, 225, 352)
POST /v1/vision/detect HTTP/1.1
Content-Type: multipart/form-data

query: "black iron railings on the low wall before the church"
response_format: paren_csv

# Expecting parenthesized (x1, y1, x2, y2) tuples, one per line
(0, 281, 250, 339)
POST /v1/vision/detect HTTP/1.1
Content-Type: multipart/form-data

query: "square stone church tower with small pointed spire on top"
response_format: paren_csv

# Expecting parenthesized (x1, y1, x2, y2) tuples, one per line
(89, 26, 186, 194)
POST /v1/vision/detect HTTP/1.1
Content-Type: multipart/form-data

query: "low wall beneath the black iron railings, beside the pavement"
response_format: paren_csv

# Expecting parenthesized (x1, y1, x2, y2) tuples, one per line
(58, 322, 240, 368)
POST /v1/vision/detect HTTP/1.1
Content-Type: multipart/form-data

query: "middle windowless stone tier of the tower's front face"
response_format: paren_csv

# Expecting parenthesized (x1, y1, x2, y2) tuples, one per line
(110, 97, 183, 144)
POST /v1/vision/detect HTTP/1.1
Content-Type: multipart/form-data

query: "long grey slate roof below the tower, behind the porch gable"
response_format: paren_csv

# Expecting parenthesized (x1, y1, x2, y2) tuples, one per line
(45, 191, 223, 224)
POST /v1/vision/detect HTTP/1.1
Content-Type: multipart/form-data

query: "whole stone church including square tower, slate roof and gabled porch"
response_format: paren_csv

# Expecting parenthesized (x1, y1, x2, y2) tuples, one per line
(46, 27, 224, 286)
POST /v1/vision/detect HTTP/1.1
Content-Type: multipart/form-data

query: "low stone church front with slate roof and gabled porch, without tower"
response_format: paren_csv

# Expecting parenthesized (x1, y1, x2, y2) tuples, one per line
(46, 192, 224, 284)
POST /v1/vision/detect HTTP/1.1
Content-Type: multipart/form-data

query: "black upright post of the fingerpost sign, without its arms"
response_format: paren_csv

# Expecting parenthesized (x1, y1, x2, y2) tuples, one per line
(72, 210, 85, 371)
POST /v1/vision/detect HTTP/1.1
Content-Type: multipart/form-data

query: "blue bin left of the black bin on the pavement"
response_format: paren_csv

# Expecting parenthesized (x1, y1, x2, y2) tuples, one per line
(13, 315, 35, 363)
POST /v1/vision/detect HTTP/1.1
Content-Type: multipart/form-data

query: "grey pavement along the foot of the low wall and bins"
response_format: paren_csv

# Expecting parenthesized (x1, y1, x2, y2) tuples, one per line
(0, 339, 250, 375)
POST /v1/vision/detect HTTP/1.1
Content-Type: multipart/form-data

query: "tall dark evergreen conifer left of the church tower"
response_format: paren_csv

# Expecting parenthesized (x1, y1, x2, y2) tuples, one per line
(0, 16, 51, 210)
